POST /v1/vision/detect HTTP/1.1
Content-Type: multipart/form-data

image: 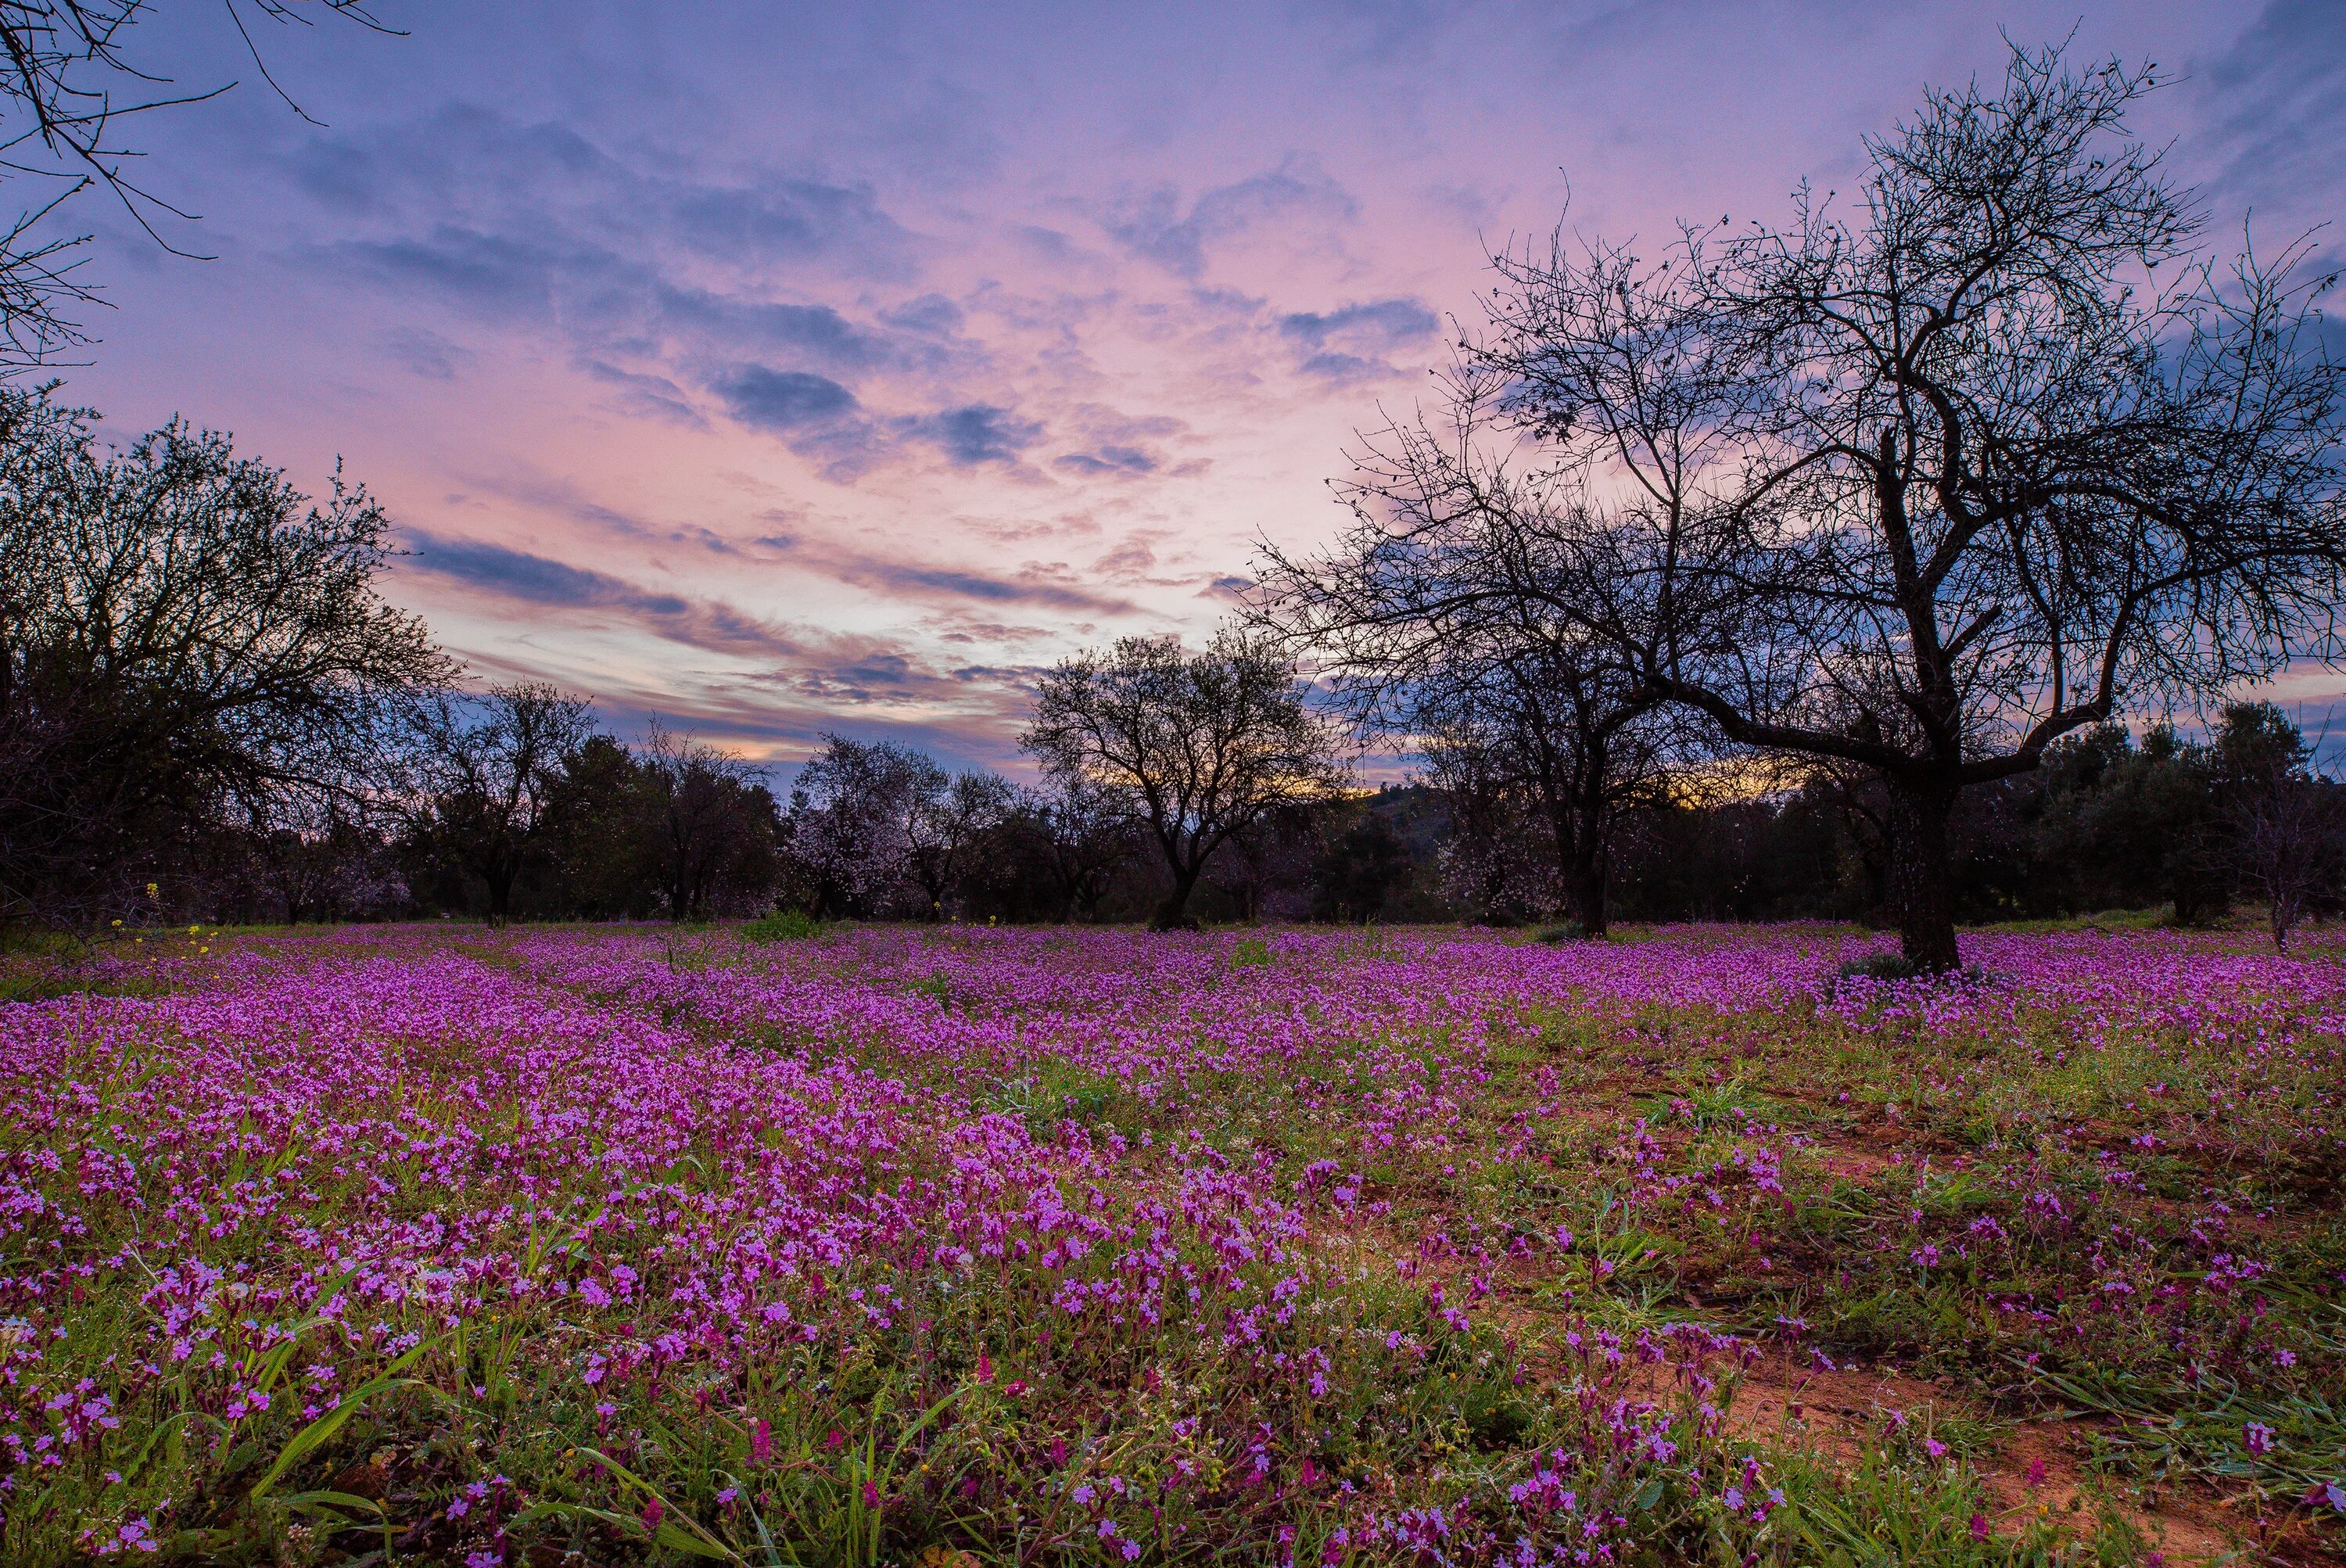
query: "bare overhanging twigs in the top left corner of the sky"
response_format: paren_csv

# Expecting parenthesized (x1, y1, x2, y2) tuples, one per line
(0, 0, 394, 368)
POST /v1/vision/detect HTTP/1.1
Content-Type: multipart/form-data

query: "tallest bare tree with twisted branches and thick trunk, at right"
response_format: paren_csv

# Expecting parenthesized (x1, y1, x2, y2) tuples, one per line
(1304, 49, 2346, 970)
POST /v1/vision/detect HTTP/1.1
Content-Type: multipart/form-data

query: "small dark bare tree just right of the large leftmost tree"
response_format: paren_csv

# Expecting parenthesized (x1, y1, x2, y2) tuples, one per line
(408, 683, 594, 925)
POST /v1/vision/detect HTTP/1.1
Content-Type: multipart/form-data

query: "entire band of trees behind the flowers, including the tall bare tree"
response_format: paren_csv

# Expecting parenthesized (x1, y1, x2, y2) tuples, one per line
(13, 49, 2346, 972)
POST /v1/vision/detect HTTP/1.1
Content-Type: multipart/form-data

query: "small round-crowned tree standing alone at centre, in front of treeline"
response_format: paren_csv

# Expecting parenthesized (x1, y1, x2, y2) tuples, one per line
(1021, 631, 1347, 930)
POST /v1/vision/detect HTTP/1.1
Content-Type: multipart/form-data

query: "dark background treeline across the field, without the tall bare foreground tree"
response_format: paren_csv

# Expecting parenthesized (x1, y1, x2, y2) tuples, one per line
(0, 368, 2346, 937)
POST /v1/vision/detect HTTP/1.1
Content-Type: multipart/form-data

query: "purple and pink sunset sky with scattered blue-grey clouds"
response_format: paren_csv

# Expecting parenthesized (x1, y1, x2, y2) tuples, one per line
(41, 0, 2346, 765)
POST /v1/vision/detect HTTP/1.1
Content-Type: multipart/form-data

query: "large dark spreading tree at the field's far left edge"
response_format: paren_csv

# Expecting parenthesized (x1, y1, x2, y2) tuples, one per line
(0, 387, 450, 916)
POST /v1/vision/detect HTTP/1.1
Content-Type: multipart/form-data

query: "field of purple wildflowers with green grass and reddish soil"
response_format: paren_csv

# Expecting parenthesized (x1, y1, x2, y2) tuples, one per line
(0, 928, 2346, 1568)
